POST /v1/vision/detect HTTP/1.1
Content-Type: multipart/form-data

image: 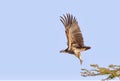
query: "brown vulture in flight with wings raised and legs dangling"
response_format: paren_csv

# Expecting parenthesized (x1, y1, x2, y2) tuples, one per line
(60, 14, 91, 64)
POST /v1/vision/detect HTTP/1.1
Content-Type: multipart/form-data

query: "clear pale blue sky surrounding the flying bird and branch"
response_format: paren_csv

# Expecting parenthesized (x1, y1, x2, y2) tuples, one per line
(0, 0, 120, 80)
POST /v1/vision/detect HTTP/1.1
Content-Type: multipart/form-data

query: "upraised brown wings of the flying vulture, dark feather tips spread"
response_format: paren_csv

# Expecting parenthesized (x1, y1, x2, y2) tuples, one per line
(60, 14, 84, 50)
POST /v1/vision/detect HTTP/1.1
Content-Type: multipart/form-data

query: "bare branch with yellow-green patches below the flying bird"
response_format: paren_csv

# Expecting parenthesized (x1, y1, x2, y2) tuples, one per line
(81, 64, 120, 81)
